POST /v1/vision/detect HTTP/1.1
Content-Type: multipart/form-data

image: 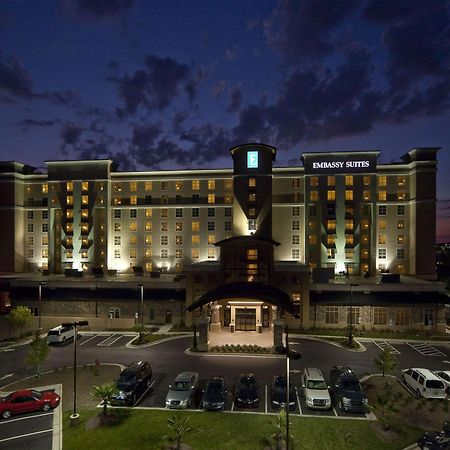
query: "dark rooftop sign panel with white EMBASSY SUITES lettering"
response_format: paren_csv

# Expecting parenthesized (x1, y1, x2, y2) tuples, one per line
(302, 152, 378, 174)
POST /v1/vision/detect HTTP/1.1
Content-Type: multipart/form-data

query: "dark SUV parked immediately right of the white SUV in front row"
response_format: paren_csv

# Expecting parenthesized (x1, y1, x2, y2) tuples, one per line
(330, 366, 367, 414)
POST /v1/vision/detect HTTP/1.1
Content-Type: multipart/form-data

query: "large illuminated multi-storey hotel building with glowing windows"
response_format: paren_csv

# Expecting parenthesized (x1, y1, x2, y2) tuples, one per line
(0, 144, 446, 331)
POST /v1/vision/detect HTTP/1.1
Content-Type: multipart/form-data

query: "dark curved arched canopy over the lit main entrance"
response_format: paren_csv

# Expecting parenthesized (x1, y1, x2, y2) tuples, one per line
(187, 282, 295, 314)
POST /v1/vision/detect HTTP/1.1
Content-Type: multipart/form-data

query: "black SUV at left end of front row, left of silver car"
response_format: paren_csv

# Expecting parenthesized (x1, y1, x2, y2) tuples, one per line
(112, 361, 152, 405)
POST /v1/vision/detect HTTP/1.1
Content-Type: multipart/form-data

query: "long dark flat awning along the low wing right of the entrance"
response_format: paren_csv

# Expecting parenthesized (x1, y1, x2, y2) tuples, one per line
(309, 291, 450, 306)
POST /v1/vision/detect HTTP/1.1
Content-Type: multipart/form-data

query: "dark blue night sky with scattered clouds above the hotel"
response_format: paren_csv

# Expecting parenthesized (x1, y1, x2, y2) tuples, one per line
(0, 0, 450, 242)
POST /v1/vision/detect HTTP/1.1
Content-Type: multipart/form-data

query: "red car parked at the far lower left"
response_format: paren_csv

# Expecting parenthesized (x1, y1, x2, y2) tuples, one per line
(0, 389, 61, 419)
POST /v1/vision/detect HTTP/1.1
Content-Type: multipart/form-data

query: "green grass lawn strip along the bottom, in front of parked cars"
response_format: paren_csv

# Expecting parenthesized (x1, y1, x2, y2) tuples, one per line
(63, 409, 421, 450)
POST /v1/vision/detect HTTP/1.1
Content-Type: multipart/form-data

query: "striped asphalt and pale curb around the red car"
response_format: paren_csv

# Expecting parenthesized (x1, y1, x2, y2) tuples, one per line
(0, 385, 62, 450)
